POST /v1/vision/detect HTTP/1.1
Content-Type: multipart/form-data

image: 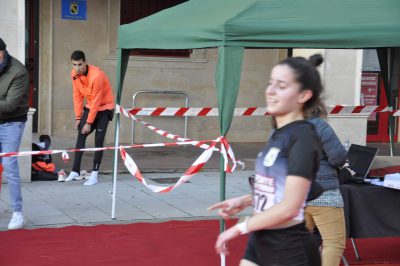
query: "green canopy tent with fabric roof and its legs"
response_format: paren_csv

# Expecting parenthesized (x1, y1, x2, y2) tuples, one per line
(112, 0, 400, 222)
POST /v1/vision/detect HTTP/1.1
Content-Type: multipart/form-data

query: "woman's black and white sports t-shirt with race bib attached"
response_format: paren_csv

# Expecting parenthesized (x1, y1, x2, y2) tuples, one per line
(253, 120, 322, 221)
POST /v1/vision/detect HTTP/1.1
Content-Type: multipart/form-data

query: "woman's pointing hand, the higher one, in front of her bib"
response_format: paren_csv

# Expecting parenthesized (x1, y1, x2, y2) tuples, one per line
(208, 195, 252, 218)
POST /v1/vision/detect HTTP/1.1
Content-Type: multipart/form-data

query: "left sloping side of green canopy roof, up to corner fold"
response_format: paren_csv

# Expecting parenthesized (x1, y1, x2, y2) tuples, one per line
(118, 0, 256, 49)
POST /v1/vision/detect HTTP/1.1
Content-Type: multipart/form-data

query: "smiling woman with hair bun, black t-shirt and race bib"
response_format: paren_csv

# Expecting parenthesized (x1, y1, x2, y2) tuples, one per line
(209, 55, 322, 266)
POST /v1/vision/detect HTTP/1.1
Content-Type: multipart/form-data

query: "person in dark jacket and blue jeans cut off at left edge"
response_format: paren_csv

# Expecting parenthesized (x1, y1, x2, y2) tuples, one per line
(0, 38, 29, 229)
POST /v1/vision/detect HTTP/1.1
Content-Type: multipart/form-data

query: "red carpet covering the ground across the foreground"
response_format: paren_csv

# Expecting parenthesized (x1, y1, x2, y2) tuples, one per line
(0, 221, 400, 266)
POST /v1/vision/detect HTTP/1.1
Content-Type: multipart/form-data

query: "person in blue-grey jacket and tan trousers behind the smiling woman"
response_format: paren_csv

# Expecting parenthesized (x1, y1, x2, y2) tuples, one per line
(305, 98, 346, 266)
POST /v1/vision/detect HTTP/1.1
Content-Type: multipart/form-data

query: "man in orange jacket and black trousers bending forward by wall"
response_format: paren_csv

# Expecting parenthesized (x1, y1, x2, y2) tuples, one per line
(65, 50, 115, 185)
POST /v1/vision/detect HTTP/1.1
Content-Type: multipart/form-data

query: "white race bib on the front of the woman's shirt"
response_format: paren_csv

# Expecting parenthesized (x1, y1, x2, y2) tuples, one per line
(253, 174, 275, 212)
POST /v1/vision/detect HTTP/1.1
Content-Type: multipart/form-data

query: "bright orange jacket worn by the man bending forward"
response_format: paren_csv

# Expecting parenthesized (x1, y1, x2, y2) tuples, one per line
(71, 65, 114, 124)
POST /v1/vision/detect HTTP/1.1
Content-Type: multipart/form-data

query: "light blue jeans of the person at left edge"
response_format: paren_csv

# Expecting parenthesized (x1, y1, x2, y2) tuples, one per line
(0, 122, 25, 212)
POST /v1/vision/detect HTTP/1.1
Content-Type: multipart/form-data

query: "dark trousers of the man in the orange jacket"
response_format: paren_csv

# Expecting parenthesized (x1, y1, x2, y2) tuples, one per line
(72, 108, 114, 173)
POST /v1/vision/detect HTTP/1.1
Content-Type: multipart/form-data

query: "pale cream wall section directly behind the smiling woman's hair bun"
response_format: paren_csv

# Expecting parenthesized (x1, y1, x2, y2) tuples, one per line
(293, 49, 368, 145)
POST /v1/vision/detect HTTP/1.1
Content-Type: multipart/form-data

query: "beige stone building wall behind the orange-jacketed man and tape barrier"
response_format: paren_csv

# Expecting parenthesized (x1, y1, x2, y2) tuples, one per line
(39, 0, 282, 143)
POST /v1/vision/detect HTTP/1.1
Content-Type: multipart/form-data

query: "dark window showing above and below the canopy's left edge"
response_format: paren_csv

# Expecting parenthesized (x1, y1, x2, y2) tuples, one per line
(120, 0, 191, 57)
